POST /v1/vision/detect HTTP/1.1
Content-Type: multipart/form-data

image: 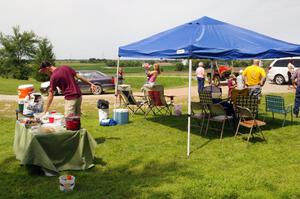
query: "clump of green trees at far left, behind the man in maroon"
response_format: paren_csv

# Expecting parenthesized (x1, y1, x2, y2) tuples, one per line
(0, 26, 55, 81)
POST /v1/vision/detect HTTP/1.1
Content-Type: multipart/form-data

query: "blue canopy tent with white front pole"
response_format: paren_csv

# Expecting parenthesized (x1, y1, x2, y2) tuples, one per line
(117, 17, 300, 156)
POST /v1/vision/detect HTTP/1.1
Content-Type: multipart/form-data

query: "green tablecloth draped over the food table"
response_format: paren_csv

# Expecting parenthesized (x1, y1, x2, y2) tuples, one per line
(14, 121, 97, 174)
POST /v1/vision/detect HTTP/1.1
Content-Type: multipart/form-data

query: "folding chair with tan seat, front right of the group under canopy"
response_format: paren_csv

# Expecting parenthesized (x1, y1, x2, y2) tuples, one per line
(234, 106, 266, 142)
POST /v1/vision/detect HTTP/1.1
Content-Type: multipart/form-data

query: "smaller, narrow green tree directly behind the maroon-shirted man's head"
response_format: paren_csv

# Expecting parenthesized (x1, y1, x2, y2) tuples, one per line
(33, 38, 55, 82)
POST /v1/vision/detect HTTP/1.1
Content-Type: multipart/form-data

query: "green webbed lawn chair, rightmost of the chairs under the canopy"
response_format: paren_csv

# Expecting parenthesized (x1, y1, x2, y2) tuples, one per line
(266, 95, 293, 126)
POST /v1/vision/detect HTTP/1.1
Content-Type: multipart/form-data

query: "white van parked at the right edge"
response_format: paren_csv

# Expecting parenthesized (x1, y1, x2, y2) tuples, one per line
(267, 57, 300, 85)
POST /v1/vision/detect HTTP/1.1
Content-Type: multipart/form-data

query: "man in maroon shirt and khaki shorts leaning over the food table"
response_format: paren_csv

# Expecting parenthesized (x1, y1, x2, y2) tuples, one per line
(40, 61, 96, 116)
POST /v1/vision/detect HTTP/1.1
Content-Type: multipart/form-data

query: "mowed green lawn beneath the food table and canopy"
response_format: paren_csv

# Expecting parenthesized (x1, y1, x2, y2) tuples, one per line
(0, 95, 300, 199)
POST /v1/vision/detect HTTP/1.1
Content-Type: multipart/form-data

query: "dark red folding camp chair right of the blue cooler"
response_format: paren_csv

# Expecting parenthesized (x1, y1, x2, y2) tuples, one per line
(143, 85, 174, 115)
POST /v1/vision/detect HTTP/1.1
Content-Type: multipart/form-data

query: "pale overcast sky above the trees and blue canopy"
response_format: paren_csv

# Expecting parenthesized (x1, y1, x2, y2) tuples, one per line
(0, 0, 300, 59)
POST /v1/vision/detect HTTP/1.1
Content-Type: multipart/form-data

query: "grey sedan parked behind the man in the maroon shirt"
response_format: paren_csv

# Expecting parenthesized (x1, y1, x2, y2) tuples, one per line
(40, 70, 115, 95)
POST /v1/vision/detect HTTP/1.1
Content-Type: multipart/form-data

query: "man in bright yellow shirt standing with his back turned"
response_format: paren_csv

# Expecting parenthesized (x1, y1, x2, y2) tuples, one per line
(243, 59, 266, 97)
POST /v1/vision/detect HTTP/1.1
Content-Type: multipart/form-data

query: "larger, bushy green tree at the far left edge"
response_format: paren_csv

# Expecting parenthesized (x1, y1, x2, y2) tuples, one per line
(0, 26, 37, 79)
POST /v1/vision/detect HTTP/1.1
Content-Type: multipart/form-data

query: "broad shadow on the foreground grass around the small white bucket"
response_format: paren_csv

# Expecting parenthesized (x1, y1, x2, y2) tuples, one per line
(0, 157, 183, 198)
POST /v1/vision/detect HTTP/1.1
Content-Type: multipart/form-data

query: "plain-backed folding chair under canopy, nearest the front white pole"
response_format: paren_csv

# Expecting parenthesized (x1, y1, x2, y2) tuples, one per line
(205, 104, 233, 139)
